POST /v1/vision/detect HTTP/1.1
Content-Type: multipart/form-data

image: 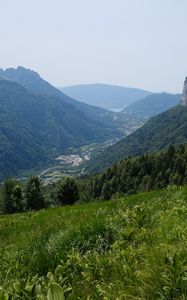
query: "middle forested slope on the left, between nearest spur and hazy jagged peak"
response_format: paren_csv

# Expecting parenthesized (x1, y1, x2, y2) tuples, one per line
(0, 80, 122, 151)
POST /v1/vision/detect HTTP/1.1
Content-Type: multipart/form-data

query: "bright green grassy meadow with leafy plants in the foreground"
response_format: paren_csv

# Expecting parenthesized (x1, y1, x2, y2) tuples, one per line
(0, 187, 187, 300)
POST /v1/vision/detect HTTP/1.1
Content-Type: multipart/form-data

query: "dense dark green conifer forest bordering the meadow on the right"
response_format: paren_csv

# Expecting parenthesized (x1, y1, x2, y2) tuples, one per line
(81, 145, 187, 201)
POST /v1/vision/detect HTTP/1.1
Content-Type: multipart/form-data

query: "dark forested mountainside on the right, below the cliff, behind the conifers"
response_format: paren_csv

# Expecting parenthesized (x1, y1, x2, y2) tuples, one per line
(86, 105, 187, 173)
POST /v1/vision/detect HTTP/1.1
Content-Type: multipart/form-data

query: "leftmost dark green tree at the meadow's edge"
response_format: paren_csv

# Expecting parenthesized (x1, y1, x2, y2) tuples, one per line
(2, 179, 23, 213)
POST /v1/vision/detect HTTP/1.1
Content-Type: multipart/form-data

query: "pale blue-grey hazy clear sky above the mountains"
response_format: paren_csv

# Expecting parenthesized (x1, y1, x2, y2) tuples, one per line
(0, 0, 187, 93)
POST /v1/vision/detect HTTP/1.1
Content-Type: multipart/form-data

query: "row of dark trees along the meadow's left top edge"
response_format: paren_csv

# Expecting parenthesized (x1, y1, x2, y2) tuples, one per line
(0, 176, 80, 214)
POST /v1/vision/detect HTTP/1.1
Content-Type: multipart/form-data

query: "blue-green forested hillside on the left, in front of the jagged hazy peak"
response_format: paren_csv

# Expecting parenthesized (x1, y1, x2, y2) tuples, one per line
(0, 79, 129, 179)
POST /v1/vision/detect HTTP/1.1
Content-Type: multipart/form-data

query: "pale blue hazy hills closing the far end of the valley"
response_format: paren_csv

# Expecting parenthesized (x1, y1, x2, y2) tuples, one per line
(61, 84, 180, 121)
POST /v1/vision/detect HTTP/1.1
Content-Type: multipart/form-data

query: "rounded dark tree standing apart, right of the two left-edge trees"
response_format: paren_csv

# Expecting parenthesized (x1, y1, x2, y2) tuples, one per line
(57, 177, 79, 205)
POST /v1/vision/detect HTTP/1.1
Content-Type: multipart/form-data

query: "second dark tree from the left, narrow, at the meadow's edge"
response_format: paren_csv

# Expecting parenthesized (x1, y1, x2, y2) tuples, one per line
(25, 176, 45, 210)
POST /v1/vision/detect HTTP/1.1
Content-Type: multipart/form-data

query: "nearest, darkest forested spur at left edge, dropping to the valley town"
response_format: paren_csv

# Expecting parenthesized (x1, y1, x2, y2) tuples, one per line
(0, 105, 51, 179)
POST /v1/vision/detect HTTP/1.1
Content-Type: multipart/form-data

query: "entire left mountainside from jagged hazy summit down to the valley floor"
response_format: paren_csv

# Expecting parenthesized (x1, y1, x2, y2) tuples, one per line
(0, 67, 140, 178)
